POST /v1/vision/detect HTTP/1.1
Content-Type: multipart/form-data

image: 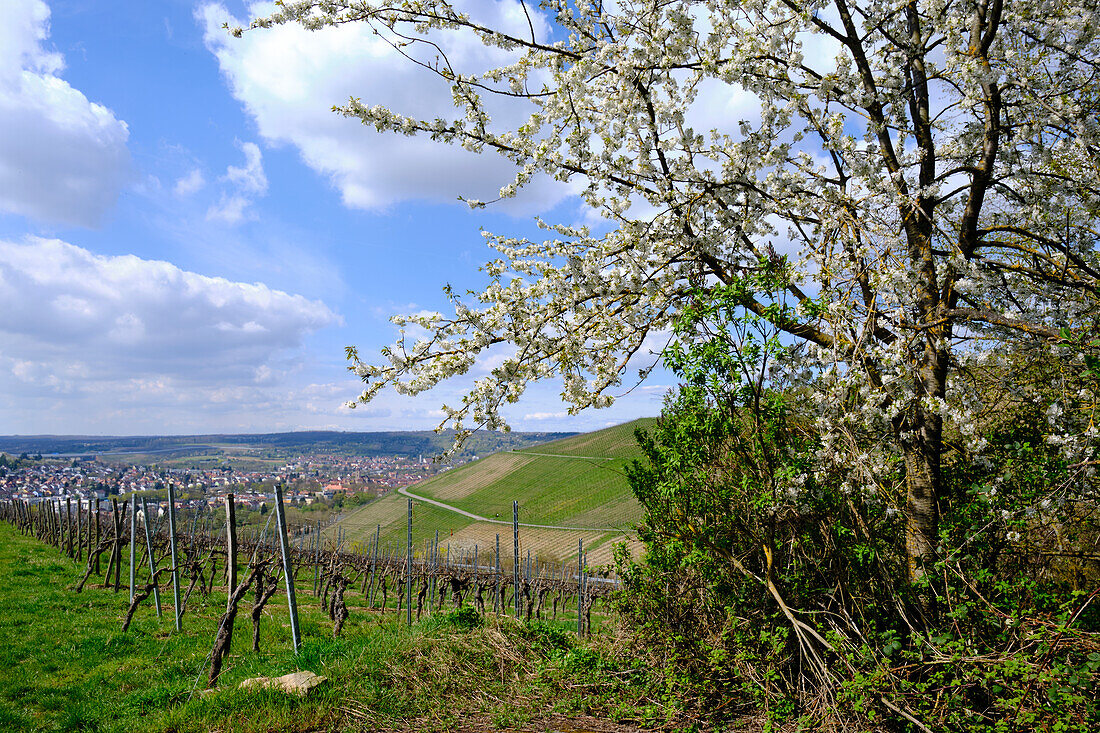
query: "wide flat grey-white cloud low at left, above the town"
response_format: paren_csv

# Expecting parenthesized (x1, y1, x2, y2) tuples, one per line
(0, 238, 340, 392)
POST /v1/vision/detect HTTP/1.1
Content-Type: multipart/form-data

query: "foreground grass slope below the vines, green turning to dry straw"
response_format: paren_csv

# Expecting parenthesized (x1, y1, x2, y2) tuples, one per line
(0, 523, 651, 733)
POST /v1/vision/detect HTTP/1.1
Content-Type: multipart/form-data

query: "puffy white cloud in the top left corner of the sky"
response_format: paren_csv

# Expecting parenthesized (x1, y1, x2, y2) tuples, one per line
(0, 0, 130, 226)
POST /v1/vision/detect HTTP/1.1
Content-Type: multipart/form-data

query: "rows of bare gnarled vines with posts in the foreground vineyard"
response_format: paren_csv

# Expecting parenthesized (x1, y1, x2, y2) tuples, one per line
(0, 482, 616, 687)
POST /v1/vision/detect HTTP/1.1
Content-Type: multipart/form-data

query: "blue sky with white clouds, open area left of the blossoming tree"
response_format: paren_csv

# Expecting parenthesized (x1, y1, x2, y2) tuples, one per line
(0, 0, 668, 435)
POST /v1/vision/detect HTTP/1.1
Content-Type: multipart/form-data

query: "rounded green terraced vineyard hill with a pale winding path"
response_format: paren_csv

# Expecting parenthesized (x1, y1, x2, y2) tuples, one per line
(329, 418, 652, 565)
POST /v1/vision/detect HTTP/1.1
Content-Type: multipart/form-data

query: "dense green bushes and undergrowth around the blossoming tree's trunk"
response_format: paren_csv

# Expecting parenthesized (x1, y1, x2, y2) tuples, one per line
(615, 288, 1100, 733)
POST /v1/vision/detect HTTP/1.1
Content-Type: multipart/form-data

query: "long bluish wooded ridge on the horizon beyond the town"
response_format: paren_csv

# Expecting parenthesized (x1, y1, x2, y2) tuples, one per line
(0, 430, 576, 458)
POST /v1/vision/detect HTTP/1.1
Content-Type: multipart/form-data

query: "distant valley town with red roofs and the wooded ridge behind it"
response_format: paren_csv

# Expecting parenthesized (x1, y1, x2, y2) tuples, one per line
(0, 431, 573, 525)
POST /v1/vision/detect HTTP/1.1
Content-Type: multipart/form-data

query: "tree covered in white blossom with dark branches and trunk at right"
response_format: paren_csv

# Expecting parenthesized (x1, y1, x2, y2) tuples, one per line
(238, 0, 1100, 580)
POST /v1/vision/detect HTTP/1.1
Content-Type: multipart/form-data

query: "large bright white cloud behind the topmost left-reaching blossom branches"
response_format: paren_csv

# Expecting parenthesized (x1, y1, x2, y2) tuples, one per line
(197, 0, 569, 211)
